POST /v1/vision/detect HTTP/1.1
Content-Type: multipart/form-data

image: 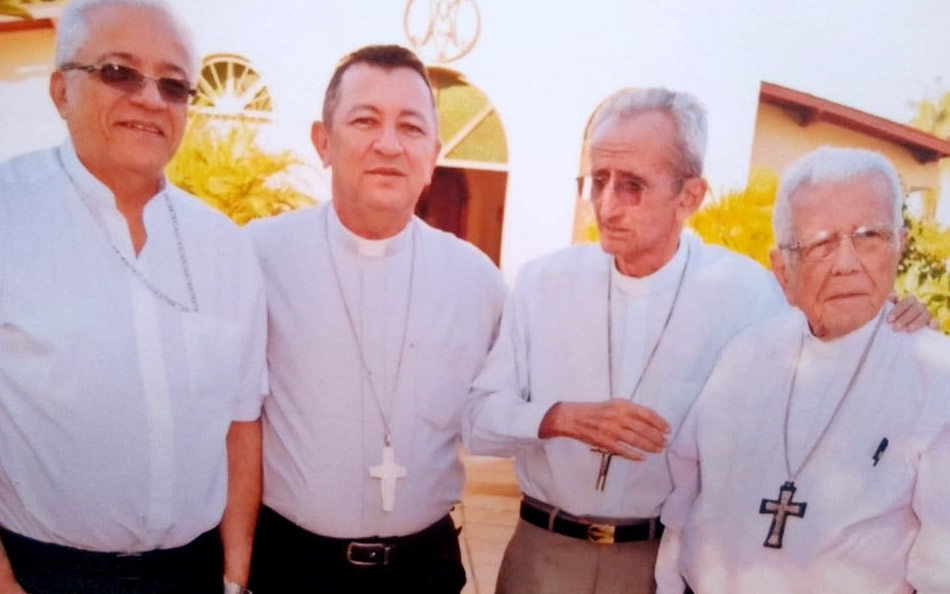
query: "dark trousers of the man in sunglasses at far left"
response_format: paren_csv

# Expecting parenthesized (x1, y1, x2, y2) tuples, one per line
(0, 529, 224, 594)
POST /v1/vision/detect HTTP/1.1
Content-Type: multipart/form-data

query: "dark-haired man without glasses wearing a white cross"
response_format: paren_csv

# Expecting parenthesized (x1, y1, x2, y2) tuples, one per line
(249, 46, 504, 594)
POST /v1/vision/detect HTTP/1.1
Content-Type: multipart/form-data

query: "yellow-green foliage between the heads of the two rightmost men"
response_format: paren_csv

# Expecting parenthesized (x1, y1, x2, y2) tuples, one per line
(687, 170, 778, 268)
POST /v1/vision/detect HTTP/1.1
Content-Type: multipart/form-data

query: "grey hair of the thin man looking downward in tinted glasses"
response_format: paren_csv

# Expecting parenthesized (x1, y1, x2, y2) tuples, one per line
(590, 87, 708, 177)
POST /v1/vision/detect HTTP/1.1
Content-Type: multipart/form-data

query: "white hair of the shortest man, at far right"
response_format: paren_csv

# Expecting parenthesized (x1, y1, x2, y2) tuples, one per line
(772, 146, 904, 245)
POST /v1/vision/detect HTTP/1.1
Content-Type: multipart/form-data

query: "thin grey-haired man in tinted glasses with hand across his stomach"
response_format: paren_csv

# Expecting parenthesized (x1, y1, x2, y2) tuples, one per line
(463, 88, 926, 594)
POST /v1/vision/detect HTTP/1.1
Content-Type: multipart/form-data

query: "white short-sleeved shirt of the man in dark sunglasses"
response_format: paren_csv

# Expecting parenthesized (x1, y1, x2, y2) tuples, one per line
(0, 142, 265, 552)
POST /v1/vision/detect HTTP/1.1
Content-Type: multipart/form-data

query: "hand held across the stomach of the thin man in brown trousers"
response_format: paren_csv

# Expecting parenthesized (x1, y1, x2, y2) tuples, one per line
(538, 400, 670, 460)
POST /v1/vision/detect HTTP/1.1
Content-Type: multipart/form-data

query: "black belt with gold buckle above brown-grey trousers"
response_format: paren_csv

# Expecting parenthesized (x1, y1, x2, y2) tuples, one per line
(521, 496, 663, 544)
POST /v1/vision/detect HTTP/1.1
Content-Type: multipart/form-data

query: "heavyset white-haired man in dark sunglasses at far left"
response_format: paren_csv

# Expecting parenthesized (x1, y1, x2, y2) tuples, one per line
(0, 0, 265, 594)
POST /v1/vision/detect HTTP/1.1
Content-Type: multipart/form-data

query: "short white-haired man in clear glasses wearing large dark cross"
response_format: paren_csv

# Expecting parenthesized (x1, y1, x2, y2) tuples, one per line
(657, 147, 950, 594)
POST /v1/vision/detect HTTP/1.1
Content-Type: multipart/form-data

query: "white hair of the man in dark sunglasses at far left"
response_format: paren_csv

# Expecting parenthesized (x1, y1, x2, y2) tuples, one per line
(56, 0, 198, 79)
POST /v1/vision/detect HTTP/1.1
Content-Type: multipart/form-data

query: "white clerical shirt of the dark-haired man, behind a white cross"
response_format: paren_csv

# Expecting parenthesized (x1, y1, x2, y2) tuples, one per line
(248, 204, 505, 538)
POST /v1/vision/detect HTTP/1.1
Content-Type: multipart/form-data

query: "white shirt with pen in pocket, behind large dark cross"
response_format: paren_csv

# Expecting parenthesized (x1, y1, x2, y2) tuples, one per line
(657, 310, 950, 594)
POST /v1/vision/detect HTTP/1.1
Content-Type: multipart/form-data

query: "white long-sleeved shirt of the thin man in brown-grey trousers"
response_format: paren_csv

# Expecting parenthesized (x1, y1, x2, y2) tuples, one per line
(463, 234, 785, 519)
